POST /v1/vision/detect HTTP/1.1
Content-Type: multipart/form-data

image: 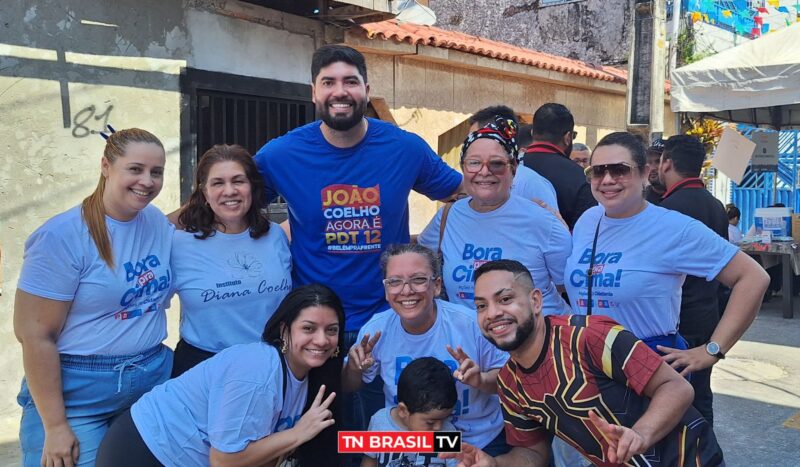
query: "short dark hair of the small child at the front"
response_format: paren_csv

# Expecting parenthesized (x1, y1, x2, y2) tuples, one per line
(397, 357, 458, 414)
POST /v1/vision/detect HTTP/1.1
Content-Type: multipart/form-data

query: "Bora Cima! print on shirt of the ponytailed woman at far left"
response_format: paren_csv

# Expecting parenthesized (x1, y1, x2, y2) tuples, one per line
(114, 255, 172, 320)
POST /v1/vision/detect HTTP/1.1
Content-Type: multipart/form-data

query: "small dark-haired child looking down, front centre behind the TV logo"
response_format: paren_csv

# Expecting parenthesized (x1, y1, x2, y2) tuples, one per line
(361, 357, 458, 467)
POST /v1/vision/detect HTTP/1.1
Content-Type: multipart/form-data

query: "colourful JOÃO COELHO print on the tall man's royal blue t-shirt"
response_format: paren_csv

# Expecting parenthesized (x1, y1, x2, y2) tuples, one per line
(321, 184, 382, 254)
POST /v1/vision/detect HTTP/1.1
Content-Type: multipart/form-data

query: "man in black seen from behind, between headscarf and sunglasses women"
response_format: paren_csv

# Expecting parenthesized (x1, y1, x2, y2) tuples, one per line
(524, 103, 597, 230)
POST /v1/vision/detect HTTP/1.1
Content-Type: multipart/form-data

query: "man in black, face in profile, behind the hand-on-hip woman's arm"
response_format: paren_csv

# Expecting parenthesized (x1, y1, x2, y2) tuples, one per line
(658, 135, 728, 424)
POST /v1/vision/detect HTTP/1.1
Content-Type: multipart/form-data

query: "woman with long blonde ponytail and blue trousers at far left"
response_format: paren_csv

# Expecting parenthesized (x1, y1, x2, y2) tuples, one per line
(14, 128, 172, 466)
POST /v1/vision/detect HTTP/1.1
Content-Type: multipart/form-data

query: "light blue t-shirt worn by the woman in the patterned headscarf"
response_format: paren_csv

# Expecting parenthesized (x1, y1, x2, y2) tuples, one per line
(417, 195, 572, 315)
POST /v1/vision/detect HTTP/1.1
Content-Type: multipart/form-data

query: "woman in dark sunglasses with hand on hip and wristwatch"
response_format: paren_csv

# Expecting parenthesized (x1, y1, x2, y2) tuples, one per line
(566, 132, 769, 375)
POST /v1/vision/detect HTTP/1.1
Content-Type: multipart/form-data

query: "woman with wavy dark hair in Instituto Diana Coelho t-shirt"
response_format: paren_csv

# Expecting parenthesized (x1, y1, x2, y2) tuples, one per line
(171, 145, 292, 377)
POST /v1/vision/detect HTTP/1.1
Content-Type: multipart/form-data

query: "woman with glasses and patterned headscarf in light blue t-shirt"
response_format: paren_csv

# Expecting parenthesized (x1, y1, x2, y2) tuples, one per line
(417, 118, 572, 315)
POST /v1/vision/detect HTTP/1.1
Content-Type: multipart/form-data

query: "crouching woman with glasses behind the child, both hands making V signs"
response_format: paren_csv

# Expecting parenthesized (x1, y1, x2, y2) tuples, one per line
(342, 244, 510, 455)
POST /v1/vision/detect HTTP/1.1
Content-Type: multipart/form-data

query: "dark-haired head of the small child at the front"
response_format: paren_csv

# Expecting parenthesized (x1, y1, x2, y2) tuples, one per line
(397, 357, 458, 431)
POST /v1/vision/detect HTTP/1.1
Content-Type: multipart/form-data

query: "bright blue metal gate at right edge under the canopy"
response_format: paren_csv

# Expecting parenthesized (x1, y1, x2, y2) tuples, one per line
(731, 125, 800, 232)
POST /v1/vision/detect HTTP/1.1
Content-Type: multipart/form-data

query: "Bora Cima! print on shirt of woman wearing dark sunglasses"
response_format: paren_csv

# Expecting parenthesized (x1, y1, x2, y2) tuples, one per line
(569, 248, 623, 308)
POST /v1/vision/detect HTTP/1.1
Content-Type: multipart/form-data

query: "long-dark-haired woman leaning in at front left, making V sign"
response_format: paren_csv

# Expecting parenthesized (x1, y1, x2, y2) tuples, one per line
(97, 285, 344, 467)
